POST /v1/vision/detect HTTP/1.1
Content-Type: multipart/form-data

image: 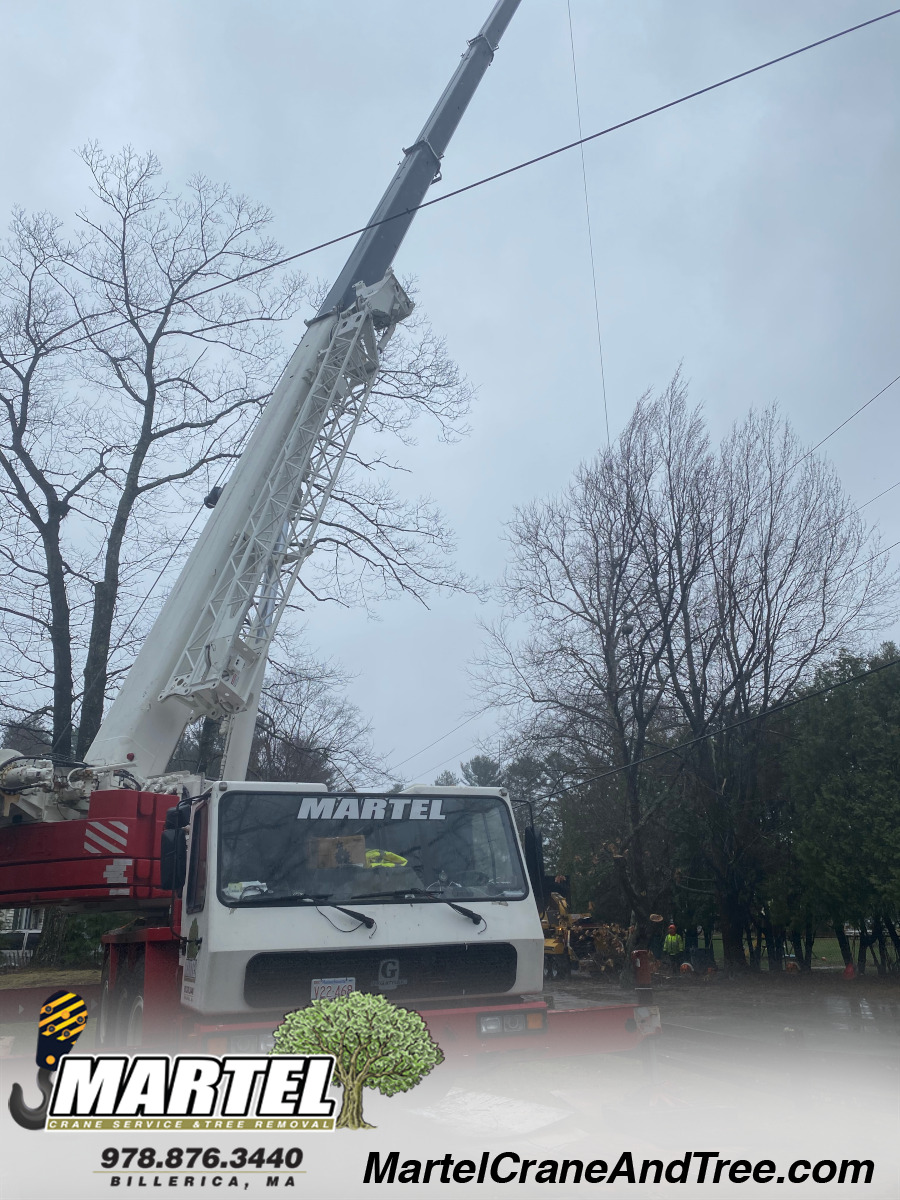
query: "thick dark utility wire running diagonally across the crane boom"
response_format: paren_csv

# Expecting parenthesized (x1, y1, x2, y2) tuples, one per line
(22, 8, 900, 360)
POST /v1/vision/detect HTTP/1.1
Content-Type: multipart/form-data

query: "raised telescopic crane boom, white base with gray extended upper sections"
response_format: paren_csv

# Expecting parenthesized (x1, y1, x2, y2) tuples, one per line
(68, 0, 520, 779)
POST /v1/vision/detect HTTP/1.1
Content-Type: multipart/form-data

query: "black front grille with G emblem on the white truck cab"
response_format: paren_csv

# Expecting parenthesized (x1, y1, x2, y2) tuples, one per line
(244, 942, 517, 1008)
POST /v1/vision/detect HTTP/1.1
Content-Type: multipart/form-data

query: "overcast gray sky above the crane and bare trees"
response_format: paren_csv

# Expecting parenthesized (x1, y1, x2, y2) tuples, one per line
(0, 0, 900, 782)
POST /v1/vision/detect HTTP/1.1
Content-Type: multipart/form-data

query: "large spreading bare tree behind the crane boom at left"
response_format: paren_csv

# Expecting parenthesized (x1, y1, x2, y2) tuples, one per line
(0, 145, 472, 757)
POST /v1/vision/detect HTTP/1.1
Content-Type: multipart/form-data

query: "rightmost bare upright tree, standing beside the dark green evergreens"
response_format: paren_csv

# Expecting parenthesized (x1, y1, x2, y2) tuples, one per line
(673, 409, 895, 966)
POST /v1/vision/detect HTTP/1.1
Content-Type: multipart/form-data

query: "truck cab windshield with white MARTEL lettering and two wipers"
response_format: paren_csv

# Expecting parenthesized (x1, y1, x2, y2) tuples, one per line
(218, 791, 527, 905)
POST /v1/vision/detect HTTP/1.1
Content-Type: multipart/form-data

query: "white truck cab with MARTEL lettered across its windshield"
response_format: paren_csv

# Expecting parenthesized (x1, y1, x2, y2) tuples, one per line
(180, 781, 544, 1015)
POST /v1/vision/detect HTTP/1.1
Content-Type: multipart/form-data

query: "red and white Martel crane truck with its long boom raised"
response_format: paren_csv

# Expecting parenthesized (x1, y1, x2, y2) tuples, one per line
(0, 0, 658, 1070)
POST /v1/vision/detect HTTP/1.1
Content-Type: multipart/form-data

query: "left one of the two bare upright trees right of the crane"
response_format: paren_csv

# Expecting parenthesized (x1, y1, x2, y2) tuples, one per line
(482, 380, 709, 941)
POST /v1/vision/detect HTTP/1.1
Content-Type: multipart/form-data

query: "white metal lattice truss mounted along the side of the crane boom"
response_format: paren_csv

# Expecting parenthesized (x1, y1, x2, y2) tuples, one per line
(160, 272, 412, 716)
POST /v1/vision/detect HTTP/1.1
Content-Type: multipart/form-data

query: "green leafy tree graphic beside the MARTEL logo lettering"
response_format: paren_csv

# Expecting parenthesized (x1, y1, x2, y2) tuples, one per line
(271, 991, 444, 1129)
